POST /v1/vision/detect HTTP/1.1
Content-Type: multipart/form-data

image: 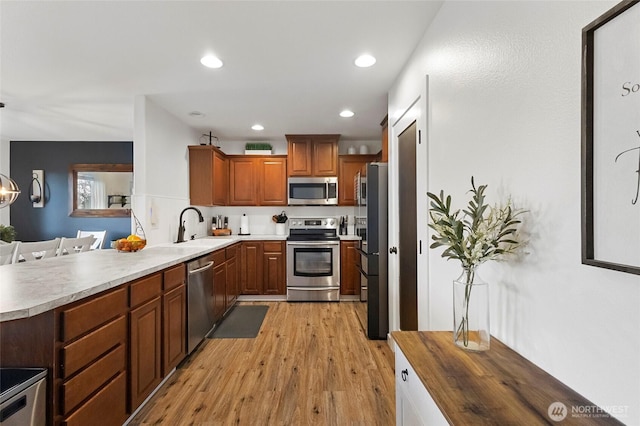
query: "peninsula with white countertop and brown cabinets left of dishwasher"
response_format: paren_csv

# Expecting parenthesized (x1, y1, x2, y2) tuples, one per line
(0, 235, 276, 425)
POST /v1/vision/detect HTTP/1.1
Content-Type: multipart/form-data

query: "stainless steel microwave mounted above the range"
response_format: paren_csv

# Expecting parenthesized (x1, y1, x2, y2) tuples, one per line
(289, 177, 338, 206)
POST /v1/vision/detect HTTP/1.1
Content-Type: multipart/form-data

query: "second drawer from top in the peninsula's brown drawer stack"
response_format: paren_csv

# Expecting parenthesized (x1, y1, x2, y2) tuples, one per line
(61, 316, 127, 378)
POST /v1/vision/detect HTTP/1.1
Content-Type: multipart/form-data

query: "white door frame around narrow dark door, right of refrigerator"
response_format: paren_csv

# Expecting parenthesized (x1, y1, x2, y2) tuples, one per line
(388, 75, 430, 331)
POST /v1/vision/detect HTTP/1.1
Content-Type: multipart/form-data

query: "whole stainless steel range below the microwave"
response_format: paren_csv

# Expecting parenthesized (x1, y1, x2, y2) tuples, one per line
(287, 217, 340, 302)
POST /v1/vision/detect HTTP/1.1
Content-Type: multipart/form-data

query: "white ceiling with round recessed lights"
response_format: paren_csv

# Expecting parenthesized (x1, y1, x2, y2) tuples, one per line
(0, 0, 441, 145)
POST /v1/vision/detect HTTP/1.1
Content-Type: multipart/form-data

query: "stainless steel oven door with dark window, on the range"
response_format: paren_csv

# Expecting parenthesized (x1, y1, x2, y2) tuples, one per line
(287, 241, 340, 289)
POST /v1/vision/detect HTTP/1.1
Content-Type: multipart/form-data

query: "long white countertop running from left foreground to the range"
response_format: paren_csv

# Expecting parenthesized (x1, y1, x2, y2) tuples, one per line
(0, 235, 286, 322)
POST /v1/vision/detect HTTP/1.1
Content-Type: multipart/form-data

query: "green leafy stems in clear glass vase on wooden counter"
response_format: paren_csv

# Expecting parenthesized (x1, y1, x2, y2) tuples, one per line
(427, 177, 524, 350)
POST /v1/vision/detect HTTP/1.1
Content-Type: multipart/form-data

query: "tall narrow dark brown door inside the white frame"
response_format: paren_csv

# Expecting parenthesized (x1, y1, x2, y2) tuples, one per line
(398, 121, 418, 330)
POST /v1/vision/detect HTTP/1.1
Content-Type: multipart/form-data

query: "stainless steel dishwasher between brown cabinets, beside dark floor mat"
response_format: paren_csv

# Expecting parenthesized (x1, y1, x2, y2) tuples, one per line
(187, 254, 215, 354)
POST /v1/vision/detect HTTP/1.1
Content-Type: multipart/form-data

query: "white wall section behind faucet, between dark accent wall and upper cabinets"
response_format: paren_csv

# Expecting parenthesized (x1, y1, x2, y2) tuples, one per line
(132, 95, 207, 244)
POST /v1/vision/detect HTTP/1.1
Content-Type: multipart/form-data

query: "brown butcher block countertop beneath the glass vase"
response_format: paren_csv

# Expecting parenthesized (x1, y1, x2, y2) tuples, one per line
(392, 331, 622, 425)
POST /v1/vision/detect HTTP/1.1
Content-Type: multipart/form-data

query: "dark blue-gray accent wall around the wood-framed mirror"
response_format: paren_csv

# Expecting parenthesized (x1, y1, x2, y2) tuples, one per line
(9, 141, 133, 243)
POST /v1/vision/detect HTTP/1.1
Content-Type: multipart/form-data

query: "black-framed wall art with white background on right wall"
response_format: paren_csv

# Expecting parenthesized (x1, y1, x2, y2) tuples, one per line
(582, 0, 640, 275)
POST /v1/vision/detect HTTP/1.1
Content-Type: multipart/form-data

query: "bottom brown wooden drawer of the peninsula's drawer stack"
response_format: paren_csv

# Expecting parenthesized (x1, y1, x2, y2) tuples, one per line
(64, 372, 127, 426)
